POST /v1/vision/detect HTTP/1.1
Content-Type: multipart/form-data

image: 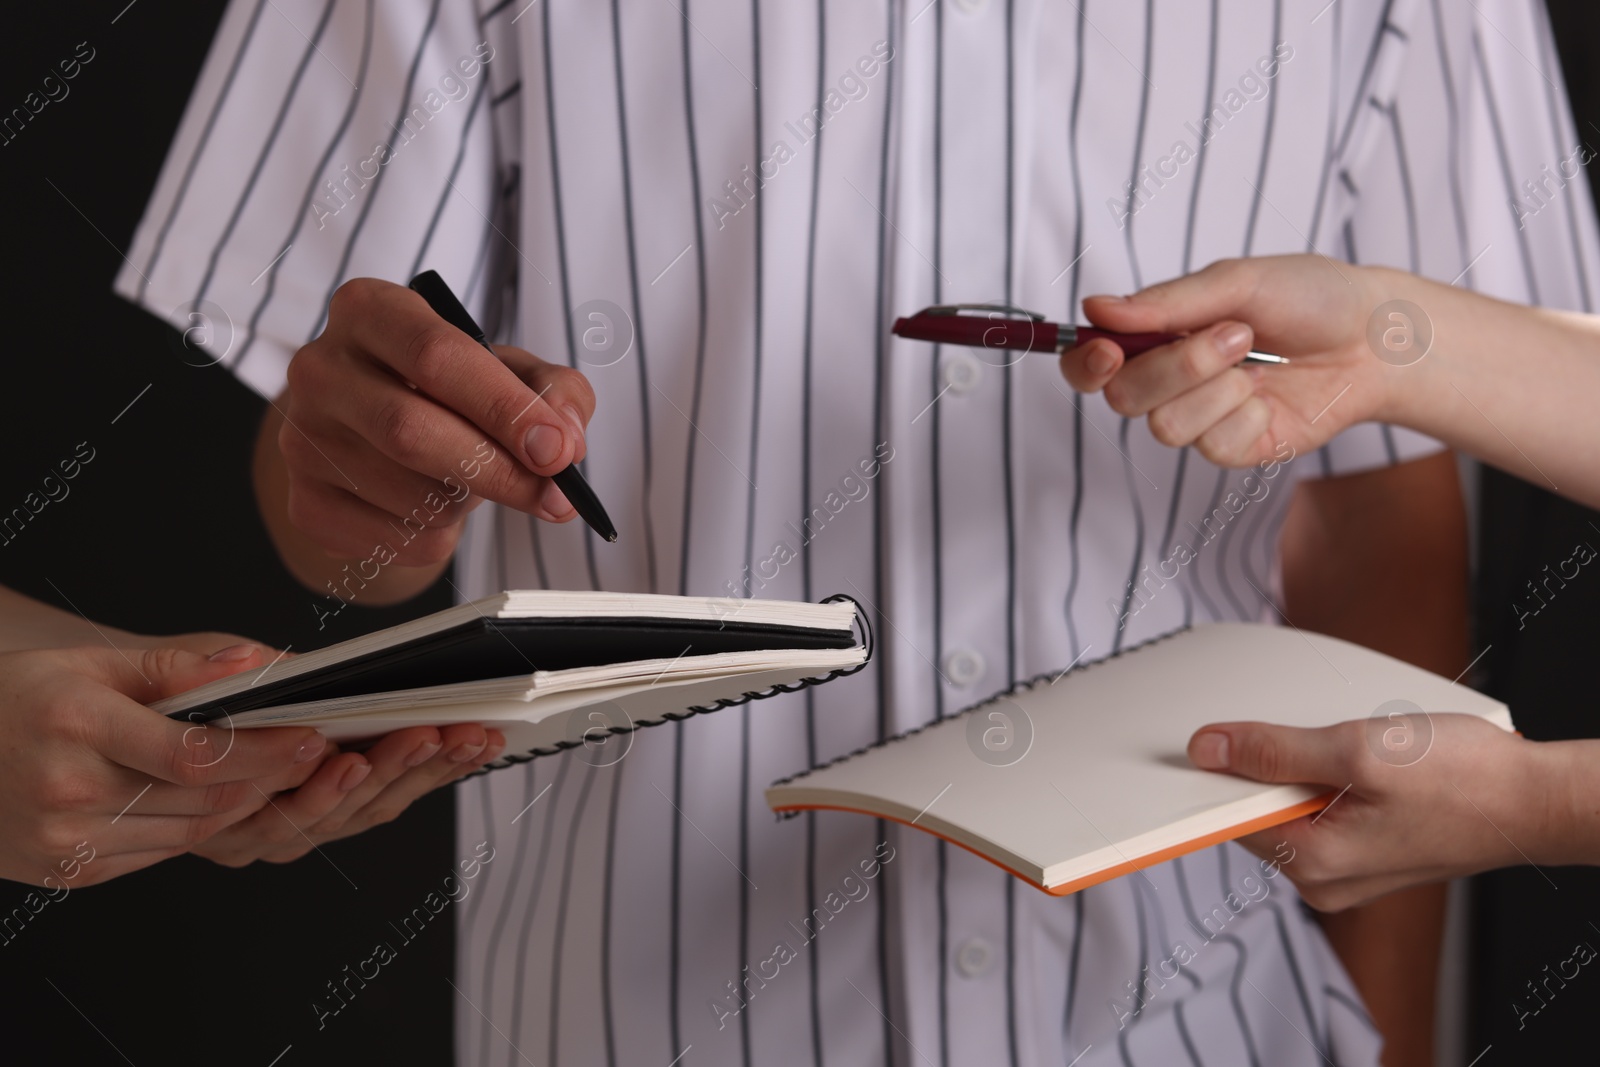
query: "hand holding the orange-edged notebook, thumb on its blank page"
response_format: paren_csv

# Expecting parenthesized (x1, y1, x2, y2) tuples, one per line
(1189, 713, 1548, 912)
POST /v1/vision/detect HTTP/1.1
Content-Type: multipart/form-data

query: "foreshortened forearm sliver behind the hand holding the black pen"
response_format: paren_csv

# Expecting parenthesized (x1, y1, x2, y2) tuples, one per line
(251, 398, 450, 606)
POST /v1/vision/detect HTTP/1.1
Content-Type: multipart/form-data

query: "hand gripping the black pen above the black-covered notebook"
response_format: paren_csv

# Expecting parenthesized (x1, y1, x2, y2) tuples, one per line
(256, 278, 595, 611)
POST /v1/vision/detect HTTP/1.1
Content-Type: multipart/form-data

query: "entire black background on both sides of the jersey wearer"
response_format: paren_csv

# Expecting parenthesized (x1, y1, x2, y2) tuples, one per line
(0, 0, 1600, 1067)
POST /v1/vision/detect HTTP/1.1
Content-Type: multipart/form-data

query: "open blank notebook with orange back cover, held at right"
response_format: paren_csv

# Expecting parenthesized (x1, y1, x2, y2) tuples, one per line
(766, 622, 1512, 896)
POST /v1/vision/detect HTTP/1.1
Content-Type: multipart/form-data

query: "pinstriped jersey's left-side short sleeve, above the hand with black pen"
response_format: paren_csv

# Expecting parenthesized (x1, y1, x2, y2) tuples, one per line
(115, 0, 518, 397)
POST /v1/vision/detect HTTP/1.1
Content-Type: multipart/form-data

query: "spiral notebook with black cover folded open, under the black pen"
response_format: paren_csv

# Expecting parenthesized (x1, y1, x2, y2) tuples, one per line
(152, 590, 872, 766)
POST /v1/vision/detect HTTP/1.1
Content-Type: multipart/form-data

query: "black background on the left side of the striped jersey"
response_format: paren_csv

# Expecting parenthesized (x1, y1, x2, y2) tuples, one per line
(0, 0, 457, 1067)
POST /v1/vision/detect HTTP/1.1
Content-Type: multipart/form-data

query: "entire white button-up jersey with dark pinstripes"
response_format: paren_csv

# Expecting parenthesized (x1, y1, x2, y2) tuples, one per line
(117, 0, 1597, 1067)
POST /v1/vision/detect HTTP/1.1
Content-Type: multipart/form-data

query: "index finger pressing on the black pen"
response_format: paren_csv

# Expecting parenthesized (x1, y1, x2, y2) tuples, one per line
(330, 280, 594, 477)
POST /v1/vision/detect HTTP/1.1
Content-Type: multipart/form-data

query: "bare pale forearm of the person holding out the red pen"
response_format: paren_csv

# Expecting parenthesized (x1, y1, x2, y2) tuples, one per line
(1373, 270, 1600, 506)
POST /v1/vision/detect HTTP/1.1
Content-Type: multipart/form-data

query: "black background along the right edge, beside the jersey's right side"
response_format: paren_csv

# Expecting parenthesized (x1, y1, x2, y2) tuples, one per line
(1469, 0, 1600, 1067)
